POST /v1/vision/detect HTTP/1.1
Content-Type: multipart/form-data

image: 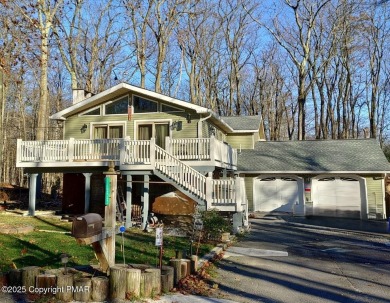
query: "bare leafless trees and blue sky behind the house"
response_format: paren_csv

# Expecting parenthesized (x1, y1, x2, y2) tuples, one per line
(0, 0, 390, 193)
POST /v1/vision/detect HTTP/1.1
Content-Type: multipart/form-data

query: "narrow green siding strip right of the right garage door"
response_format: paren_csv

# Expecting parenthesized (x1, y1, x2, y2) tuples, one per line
(366, 177, 385, 219)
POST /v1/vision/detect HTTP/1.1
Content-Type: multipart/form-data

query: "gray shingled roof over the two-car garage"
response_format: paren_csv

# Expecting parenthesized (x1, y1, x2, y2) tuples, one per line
(238, 139, 390, 173)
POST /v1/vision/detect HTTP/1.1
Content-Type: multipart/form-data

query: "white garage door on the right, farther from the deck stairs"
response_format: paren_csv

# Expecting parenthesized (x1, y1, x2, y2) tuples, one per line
(312, 176, 361, 218)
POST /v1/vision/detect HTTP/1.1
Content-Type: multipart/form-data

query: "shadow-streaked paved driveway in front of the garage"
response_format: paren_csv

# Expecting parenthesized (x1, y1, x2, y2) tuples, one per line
(213, 215, 390, 303)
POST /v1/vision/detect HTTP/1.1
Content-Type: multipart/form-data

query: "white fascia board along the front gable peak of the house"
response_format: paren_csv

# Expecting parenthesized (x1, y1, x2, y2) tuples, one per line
(50, 83, 211, 120)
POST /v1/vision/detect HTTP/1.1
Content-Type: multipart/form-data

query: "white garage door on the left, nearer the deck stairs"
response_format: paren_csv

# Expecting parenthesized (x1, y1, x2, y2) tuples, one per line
(253, 177, 301, 212)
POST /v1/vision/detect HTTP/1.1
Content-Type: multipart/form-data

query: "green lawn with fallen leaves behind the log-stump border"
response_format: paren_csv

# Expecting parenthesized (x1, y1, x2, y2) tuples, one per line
(0, 213, 212, 272)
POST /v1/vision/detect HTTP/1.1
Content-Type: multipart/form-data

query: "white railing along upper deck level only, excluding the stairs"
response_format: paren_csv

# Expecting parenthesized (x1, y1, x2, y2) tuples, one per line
(17, 137, 237, 167)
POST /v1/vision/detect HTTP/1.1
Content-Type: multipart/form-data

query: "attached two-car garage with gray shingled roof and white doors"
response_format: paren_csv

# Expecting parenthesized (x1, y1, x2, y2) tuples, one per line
(237, 139, 390, 220)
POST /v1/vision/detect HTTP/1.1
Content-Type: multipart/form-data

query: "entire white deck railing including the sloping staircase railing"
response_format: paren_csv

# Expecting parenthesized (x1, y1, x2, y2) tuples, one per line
(17, 138, 245, 207)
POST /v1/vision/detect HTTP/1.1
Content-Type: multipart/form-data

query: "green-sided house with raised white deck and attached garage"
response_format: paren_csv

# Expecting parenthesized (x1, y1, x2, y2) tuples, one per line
(16, 83, 390, 230)
